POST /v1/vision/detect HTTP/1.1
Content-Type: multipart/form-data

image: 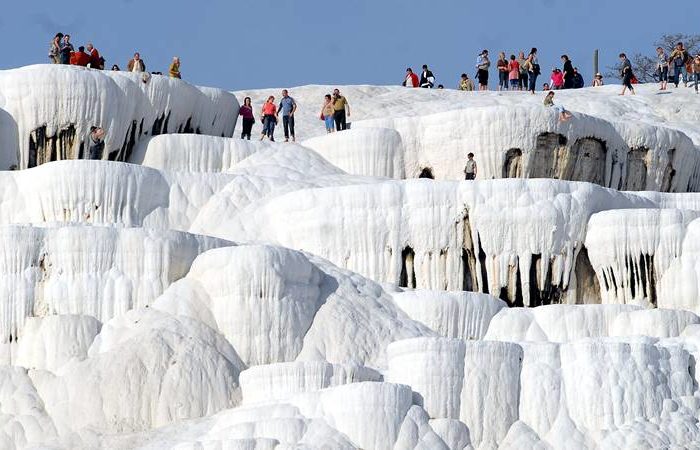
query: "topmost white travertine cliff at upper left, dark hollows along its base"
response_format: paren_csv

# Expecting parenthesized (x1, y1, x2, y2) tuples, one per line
(0, 65, 238, 168)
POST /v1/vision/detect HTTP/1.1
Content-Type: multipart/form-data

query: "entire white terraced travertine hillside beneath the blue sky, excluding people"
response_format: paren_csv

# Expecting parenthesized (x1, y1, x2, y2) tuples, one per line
(0, 65, 700, 450)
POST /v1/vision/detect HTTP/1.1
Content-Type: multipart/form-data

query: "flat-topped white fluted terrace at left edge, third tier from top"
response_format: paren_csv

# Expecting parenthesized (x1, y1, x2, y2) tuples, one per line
(0, 225, 231, 346)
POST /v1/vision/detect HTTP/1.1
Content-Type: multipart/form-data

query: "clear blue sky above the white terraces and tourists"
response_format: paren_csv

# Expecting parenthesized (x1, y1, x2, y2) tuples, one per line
(0, 0, 700, 90)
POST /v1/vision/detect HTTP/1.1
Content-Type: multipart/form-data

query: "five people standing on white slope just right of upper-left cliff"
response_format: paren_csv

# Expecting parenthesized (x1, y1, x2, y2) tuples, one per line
(239, 89, 350, 142)
